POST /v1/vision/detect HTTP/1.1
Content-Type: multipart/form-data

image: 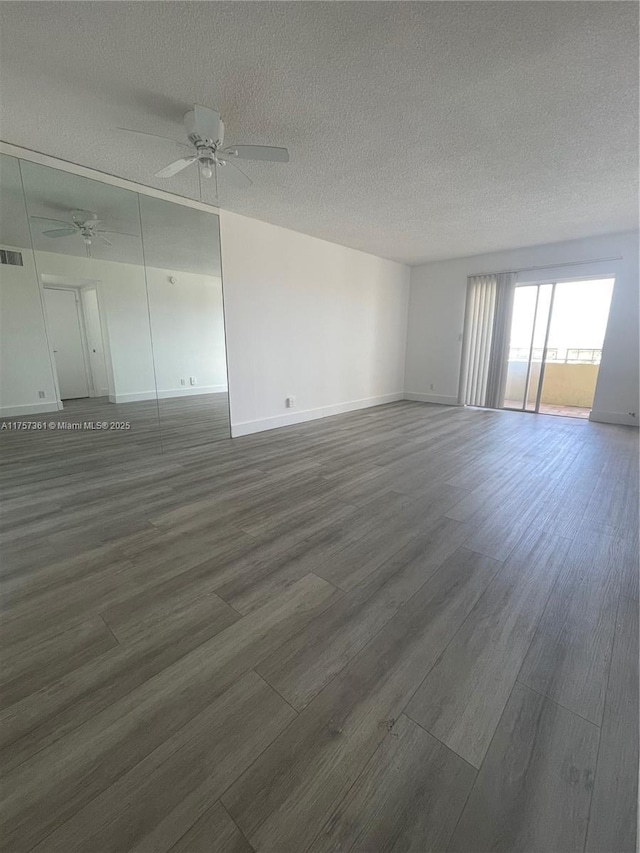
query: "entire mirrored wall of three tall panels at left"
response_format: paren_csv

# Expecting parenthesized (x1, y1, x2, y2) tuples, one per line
(0, 155, 230, 451)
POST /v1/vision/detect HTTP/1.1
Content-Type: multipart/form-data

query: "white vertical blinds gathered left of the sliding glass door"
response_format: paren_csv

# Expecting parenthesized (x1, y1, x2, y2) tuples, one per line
(459, 273, 516, 408)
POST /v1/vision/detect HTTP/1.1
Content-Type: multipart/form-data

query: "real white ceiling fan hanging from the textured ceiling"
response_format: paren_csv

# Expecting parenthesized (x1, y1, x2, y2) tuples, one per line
(118, 104, 289, 196)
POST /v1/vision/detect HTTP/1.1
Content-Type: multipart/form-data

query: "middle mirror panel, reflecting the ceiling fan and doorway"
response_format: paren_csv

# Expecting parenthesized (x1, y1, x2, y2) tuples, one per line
(21, 161, 160, 456)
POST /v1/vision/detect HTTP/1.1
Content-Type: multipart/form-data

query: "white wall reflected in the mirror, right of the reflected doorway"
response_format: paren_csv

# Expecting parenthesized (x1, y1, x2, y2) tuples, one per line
(35, 252, 227, 403)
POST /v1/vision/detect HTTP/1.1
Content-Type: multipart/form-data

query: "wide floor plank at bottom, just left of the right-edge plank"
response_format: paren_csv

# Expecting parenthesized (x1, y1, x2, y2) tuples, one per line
(448, 683, 602, 853)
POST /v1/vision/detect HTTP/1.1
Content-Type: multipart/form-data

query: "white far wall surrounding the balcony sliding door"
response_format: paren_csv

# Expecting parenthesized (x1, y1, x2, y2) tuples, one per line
(405, 232, 640, 424)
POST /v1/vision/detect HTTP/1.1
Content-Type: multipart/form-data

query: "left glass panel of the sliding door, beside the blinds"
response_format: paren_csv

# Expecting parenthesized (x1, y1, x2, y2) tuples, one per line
(503, 284, 555, 412)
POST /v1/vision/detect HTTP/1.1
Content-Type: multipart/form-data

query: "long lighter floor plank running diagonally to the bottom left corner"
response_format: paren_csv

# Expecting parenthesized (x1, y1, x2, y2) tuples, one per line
(2, 575, 336, 853)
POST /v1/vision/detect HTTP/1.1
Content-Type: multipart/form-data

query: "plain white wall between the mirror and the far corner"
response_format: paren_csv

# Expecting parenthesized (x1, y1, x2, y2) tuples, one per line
(220, 211, 409, 435)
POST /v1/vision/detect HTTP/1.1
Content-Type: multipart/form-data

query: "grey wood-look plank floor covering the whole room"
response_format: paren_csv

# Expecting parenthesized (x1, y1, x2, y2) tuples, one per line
(0, 402, 638, 853)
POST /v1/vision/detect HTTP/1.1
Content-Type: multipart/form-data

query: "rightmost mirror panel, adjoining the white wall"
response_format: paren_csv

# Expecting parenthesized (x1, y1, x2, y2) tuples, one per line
(140, 195, 230, 451)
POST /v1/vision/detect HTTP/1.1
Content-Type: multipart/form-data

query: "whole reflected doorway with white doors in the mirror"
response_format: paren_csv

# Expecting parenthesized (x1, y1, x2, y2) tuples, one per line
(44, 284, 108, 401)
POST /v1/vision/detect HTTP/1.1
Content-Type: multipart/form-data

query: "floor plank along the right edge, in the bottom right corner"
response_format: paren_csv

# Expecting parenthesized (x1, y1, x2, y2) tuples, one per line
(586, 597, 639, 853)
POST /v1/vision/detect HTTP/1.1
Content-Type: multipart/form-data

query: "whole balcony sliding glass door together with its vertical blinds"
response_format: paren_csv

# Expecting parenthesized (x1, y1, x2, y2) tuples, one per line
(459, 273, 614, 418)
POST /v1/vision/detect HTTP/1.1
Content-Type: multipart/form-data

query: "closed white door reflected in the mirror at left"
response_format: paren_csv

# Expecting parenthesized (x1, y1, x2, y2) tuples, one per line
(44, 287, 89, 400)
